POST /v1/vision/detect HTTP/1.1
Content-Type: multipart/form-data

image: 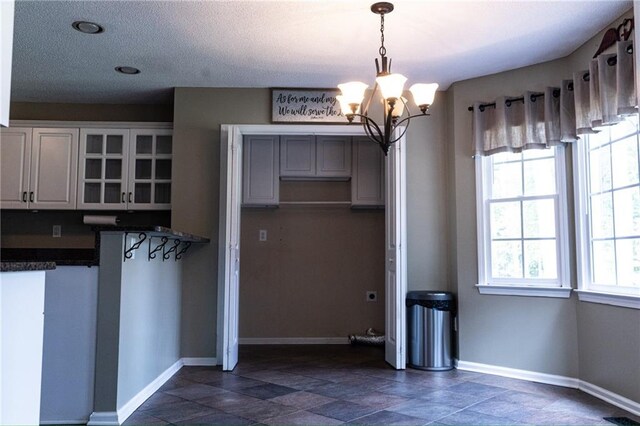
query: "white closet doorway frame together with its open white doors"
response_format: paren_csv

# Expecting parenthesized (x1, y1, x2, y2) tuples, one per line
(217, 125, 406, 370)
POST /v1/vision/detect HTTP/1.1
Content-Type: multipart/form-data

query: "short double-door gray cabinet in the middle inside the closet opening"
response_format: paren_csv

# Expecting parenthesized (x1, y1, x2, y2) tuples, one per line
(280, 135, 351, 180)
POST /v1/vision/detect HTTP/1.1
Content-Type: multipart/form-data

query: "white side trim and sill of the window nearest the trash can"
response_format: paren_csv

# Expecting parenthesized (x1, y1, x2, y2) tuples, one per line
(475, 146, 572, 298)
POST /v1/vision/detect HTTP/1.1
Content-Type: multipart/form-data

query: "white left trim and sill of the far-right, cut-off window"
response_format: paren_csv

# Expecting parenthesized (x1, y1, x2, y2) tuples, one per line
(573, 127, 640, 309)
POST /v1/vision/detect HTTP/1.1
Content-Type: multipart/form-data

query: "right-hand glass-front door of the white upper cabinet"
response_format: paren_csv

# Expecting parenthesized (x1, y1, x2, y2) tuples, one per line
(127, 129, 173, 210)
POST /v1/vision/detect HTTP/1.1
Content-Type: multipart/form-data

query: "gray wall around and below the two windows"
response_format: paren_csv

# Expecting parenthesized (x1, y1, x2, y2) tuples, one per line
(449, 9, 640, 401)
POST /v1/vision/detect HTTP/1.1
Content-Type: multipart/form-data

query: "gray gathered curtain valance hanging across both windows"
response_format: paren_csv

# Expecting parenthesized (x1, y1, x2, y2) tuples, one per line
(473, 40, 638, 155)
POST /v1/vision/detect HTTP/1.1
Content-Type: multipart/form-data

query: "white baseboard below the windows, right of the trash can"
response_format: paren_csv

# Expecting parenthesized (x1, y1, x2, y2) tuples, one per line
(454, 360, 640, 416)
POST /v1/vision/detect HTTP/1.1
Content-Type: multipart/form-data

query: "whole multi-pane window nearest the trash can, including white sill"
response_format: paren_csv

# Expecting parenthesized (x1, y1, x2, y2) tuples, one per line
(476, 147, 571, 297)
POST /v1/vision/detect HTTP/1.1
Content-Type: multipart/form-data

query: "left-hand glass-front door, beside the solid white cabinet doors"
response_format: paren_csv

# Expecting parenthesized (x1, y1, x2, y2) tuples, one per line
(78, 129, 128, 210)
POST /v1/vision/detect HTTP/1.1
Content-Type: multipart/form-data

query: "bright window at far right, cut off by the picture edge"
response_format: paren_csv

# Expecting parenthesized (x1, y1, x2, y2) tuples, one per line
(574, 116, 640, 307)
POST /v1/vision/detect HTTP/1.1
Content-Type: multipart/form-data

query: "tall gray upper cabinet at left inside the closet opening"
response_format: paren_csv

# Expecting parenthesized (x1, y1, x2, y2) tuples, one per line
(242, 135, 280, 207)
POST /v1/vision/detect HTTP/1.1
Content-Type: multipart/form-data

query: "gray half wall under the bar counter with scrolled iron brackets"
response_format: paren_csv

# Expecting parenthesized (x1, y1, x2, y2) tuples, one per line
(94, 232, 182, 412)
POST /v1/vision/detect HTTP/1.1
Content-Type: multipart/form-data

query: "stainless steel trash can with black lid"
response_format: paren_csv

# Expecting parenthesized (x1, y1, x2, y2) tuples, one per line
(406, 291, 455, 371)
